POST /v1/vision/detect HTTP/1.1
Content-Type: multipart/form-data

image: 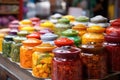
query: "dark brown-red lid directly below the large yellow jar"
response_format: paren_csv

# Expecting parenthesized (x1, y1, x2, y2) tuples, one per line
(80, 42, 104, 54)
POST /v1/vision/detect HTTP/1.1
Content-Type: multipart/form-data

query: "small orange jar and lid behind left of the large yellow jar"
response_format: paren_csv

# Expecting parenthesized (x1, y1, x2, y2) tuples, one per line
(72, 24, 87, 37)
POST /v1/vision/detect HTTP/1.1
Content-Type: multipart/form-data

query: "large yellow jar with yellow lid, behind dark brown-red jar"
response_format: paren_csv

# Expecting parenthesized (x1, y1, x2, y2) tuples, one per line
(82, 25, 105, 44)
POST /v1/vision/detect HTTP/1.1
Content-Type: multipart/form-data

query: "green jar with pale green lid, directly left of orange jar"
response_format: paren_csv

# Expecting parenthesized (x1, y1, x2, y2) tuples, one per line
(10, 36, 27, 62)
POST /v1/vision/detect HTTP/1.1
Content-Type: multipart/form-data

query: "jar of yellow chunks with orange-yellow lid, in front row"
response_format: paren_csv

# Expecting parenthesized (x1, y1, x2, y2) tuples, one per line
(32, 43, 55, 78)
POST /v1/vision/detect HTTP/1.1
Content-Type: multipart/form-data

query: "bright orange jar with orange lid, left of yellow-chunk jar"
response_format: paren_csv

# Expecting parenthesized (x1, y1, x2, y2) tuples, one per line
(20, 38, 42, 69)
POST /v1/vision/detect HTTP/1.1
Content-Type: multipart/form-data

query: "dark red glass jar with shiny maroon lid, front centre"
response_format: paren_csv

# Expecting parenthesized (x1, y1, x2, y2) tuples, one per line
(52, 46, 83, 80)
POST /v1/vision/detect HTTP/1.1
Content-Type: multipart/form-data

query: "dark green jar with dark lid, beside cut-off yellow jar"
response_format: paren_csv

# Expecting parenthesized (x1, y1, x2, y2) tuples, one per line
(2, 35, 14, 57)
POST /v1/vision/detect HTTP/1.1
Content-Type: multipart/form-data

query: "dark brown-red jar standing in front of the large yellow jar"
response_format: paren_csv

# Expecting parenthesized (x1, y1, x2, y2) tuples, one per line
(80, 42, 107, 80)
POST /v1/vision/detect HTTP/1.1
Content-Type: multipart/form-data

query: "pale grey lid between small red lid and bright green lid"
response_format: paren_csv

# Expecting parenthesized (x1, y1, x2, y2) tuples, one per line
(41, 33, 58, 41)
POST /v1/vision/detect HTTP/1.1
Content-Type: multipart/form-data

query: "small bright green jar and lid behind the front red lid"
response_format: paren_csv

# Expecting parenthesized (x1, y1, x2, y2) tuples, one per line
(62, 29, 81, 47)
